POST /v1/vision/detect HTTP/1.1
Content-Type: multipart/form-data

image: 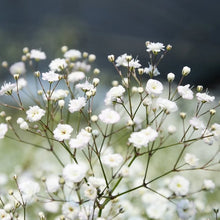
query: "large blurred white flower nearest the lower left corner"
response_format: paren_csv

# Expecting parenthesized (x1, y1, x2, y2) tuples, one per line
(19, 179, 40, 203)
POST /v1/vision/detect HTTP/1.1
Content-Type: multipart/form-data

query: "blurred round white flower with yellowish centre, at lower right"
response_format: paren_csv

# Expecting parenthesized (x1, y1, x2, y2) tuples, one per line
(169, 176, 189, 196)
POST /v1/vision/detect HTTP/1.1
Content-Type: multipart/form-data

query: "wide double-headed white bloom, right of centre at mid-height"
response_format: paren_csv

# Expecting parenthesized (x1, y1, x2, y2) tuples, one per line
(129, 127, 158, 148)
